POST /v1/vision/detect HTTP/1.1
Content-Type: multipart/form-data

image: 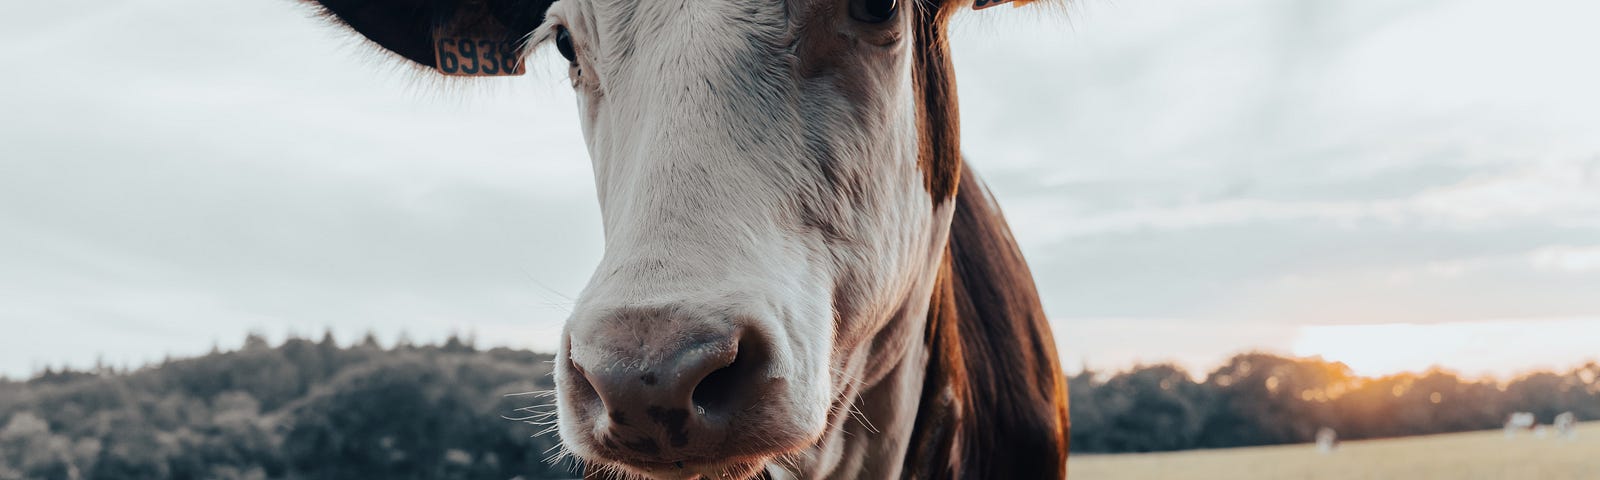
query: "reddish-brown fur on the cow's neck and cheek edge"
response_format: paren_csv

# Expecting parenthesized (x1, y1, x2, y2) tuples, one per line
(904, 2, 1070, 478)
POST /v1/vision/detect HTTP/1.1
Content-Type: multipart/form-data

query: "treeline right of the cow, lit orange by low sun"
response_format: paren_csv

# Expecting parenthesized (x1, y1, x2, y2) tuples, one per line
(1069, 354, 1600, 453)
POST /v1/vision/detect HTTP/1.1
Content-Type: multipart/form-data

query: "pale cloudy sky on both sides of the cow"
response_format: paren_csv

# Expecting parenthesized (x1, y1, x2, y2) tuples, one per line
(0, 0, 1600, 378)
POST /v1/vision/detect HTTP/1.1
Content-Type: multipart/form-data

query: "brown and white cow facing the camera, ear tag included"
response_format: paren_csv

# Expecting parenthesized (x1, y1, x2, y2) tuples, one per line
(306, 0, 1069, 478)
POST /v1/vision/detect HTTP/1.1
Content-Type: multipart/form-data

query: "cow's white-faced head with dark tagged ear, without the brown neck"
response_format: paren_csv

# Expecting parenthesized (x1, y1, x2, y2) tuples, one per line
(305, 0, 1043, 478)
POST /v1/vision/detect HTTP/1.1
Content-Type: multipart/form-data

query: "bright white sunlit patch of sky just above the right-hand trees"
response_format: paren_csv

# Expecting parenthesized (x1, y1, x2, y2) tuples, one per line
(1293, 318, 1600, 379)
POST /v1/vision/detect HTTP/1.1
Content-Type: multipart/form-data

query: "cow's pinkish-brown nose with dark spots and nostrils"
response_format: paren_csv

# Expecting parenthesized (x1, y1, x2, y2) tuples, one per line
(571, 326, 770, 461)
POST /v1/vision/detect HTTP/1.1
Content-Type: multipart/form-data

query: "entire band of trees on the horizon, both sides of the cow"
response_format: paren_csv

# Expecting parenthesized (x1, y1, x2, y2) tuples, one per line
(0, 336, 1600, 478)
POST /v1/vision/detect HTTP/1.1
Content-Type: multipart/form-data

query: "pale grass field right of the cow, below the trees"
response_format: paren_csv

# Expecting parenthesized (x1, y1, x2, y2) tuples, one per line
(1069, 422, 1600, 480)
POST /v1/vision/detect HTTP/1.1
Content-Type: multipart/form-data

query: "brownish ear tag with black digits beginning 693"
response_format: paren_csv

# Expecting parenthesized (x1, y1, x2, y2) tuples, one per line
(434, 2, 528, 77)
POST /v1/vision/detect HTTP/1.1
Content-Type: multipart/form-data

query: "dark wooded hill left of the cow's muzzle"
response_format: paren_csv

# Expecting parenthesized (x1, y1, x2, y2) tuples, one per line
(0, 336, 574, 480)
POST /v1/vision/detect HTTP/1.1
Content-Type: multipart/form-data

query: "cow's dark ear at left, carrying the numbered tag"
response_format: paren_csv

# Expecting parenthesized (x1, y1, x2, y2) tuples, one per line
(304, 0, 555, 75)
